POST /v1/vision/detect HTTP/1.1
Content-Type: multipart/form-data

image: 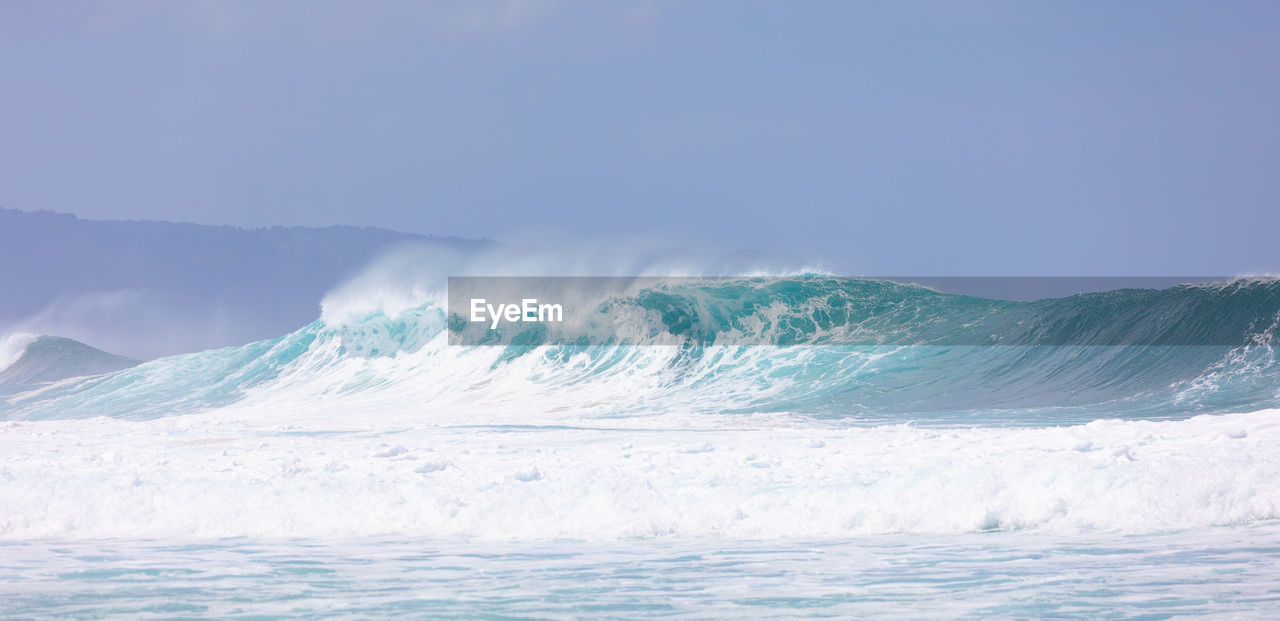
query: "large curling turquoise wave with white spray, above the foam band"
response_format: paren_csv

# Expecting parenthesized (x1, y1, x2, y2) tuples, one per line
(0, 277, 1280, 424)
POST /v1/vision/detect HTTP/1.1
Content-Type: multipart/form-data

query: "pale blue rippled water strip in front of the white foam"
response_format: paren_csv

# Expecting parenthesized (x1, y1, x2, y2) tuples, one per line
(0, 522, 1280, 618)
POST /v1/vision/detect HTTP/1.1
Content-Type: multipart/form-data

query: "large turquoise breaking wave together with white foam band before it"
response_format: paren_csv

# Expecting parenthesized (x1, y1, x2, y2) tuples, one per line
(0, 277, 1280, 540)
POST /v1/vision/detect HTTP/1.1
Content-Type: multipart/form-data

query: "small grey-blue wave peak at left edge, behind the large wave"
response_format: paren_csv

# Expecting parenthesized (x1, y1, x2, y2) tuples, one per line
(0, 334, 138, 385)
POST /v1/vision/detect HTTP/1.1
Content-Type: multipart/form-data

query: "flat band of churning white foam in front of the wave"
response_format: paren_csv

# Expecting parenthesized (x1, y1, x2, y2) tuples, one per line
(0, 403, 1280, 540)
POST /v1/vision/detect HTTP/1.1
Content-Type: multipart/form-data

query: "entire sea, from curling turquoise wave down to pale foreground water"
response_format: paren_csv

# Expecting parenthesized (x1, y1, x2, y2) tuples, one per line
(0, 277, 1280, 618)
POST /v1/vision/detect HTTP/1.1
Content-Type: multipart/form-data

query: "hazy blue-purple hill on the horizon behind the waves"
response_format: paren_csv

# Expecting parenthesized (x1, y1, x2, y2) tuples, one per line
(0, 209, 490, 357)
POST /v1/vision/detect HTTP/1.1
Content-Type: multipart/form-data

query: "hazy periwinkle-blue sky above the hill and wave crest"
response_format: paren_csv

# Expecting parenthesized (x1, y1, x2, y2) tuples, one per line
(0, 0, 1280, 274)
